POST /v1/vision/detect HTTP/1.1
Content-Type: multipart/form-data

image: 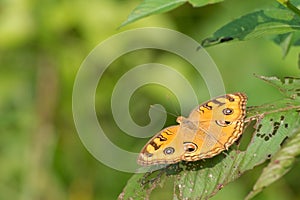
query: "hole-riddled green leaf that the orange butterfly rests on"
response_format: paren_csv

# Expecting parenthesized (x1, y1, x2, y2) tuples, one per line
(121, 76, 300, 200)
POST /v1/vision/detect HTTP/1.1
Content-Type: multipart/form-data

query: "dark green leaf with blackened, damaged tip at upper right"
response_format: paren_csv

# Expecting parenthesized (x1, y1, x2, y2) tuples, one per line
(202, 8, 300, 47)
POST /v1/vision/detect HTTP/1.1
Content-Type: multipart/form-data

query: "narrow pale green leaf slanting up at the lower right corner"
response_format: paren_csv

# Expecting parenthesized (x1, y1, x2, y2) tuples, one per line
(246, 129, 300, 199)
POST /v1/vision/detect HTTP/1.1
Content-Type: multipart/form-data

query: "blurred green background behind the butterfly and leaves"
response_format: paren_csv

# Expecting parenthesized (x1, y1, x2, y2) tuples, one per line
(0, 0, 300, 200)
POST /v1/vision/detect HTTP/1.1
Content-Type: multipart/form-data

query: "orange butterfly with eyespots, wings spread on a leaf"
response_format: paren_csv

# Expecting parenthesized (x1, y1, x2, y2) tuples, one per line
(137, 93, 247, 166)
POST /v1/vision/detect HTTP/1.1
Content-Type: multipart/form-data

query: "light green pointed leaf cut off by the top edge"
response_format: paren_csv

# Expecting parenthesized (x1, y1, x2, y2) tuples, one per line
(120, 0, 223, 27)
